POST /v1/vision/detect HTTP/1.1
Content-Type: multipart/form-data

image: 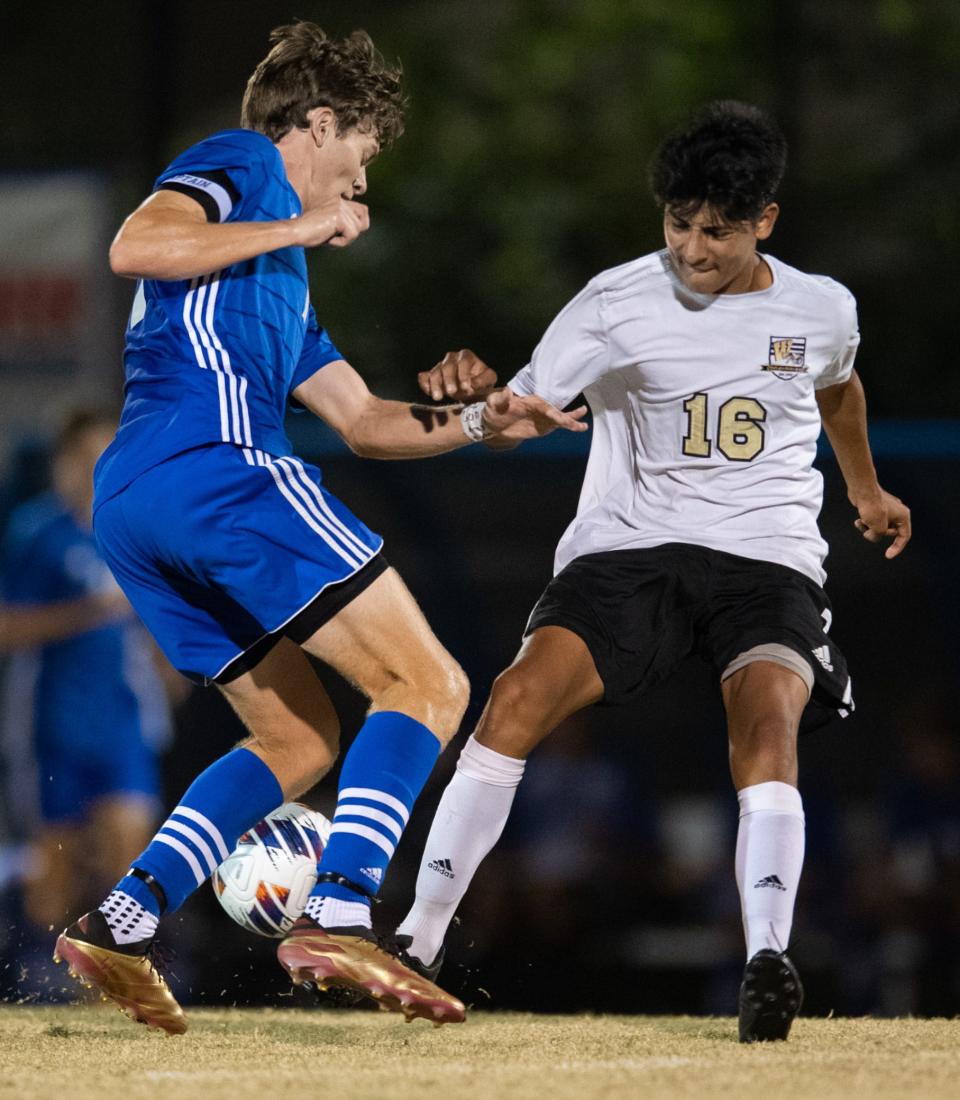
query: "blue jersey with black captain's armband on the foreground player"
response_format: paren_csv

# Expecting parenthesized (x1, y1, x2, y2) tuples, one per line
(95, 130, 342, 505)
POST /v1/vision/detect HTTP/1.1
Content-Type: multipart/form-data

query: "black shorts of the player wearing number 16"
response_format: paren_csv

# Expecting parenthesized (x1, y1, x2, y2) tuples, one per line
(526, 542, 853, 729)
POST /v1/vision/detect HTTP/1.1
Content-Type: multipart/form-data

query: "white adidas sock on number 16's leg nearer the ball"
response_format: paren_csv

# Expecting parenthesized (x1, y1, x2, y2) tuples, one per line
(397, 737, 526, 965)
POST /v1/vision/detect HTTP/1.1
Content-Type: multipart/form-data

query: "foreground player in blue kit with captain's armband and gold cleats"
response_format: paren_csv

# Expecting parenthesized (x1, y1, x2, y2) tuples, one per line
(56, 22, 584, 1033)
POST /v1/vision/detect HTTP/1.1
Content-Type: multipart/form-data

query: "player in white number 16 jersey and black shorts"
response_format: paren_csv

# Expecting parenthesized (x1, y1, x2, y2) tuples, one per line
(398, 101, 911, 1042)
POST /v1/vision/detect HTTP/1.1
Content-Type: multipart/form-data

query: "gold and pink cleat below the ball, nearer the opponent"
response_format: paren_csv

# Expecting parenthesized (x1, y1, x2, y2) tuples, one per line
(277, 917, 465, 1026)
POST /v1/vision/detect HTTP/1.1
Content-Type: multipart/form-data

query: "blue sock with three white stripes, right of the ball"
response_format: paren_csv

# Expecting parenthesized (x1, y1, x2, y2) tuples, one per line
(310, 711, 440, 902)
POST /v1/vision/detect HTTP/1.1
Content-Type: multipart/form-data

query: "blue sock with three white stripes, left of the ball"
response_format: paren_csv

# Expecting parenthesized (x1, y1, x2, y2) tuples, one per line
(115, 749, 284, 916)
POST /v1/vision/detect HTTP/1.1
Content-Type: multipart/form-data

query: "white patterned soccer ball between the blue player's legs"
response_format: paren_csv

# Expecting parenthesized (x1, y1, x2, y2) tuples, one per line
(211, 802, 331, 939)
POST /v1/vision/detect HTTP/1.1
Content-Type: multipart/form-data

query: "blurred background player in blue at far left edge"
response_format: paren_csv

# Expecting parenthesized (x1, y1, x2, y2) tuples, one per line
(0, 410, 180, 932)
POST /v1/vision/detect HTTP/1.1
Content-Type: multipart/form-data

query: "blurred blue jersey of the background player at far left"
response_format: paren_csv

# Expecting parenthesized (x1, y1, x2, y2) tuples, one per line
(3, 494, 169, 751)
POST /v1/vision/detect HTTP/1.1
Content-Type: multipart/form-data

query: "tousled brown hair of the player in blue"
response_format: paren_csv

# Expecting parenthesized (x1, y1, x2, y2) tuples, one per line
(241, 22, 405, 146)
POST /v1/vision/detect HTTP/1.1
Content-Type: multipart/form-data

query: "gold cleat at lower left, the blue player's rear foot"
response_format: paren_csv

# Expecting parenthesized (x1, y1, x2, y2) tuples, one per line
(54, 910, 187, 1035)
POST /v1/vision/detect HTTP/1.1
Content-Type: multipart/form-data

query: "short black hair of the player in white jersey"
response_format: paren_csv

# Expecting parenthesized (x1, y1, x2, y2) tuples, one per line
(650, 99, 786, 222)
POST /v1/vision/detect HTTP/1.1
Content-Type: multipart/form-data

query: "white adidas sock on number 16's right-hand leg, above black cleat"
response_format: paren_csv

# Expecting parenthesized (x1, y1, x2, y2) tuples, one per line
(737, 782, 804, 959)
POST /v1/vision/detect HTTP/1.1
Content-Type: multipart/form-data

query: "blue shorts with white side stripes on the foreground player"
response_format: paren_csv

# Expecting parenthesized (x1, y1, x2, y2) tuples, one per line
(93, 443, 383, 683)
